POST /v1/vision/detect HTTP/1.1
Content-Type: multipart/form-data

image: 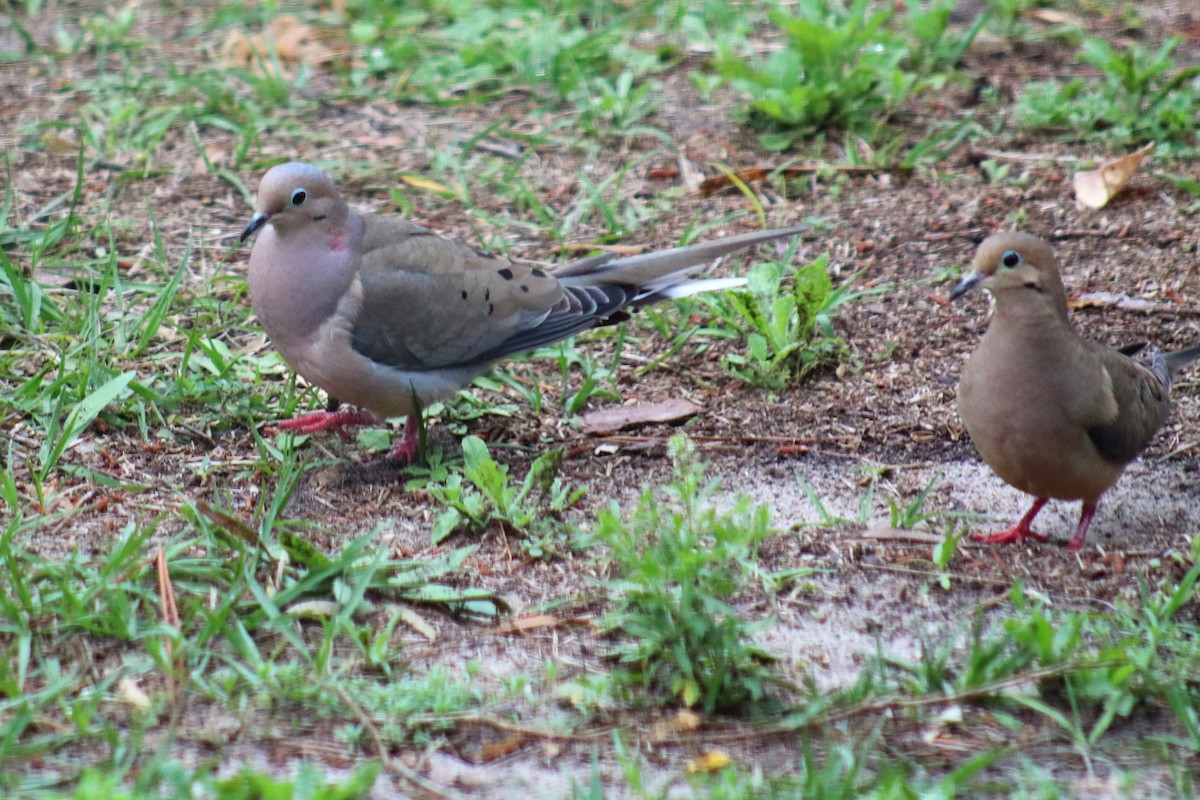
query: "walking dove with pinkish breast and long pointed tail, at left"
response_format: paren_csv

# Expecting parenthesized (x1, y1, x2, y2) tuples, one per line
(241, 162, 803, 461)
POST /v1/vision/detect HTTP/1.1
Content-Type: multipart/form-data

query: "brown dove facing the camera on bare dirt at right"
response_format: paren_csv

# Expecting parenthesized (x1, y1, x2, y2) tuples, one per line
(950, 233, 1200, 551)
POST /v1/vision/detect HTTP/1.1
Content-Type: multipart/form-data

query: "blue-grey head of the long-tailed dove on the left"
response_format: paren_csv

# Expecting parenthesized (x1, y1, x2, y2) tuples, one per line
(241, 161, 349, 241)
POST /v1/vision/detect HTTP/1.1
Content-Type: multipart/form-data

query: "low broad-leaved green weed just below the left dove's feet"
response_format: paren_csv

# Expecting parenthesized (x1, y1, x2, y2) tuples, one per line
(427, 437, 583, 558)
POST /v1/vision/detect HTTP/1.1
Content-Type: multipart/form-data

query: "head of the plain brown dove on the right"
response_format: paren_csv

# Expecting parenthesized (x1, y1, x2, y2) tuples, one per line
(950, 231, 1067, 314)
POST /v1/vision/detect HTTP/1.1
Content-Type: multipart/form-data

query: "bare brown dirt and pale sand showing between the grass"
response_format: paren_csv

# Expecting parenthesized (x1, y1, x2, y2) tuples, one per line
(7, 2, 1200, 798)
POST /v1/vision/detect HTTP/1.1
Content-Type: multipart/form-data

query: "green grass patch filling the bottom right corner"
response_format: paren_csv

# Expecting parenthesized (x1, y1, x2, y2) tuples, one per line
(574, 556, 1200, 798)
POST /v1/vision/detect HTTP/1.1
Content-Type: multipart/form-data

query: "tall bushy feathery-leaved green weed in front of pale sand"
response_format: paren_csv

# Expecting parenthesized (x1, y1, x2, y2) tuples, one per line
(595, 435, 773, 712)
